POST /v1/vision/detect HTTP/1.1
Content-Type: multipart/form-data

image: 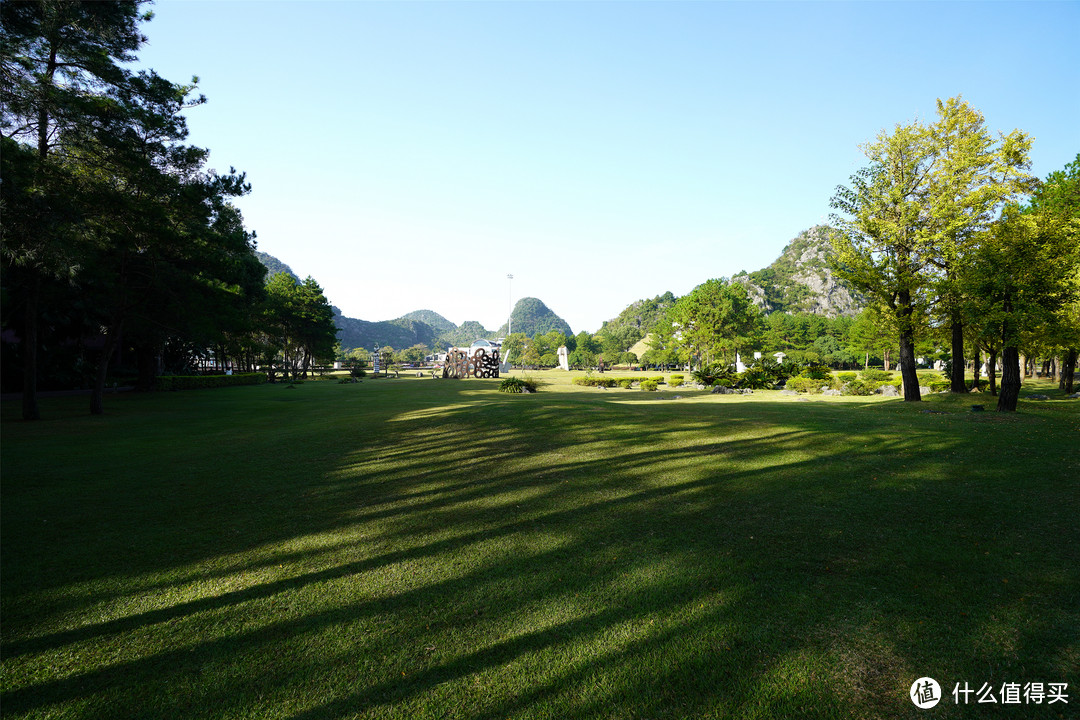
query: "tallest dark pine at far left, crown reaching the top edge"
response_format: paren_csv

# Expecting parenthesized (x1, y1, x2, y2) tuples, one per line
(0, 0, 150, 420)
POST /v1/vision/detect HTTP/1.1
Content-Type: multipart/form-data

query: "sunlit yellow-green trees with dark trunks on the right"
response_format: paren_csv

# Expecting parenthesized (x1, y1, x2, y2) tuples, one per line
(833, 97, 1080, 411)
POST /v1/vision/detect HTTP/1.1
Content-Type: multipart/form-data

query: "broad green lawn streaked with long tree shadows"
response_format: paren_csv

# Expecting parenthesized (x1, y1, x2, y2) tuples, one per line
(0, 373, 1080, 720)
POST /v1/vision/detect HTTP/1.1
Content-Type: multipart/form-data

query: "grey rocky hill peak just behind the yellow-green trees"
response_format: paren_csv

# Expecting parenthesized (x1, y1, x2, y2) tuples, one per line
(731, 226, 866, 317)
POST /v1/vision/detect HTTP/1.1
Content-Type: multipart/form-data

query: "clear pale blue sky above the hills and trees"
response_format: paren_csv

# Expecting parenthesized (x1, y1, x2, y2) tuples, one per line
(132, 0, 1080, 332)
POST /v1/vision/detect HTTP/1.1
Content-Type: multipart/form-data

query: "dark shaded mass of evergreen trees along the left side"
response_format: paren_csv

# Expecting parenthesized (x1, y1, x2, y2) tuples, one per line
(0, 0, 333, 420)
